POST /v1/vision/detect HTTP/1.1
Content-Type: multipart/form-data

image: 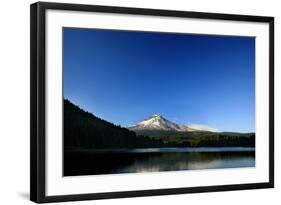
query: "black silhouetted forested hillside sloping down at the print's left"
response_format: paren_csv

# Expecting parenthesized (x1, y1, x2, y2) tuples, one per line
(64, 100, 136, 148)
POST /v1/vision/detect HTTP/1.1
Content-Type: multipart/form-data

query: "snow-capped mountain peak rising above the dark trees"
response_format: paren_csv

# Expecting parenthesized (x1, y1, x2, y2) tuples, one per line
(128, 114, 198, 132)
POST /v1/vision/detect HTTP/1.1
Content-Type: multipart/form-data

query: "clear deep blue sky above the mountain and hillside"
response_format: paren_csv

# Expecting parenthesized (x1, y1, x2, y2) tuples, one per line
(63, 28, 255, 132)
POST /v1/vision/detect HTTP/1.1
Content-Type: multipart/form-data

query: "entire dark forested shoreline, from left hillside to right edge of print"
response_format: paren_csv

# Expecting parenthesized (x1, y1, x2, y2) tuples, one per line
(64, 100, 255, 149)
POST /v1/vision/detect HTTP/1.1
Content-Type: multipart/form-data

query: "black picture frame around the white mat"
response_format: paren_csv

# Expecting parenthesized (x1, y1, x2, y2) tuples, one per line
(30, 2, 274, 203)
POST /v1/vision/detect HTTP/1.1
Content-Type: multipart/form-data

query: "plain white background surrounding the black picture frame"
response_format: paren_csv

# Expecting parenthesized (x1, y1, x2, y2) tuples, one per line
(0, 0, 276, 205)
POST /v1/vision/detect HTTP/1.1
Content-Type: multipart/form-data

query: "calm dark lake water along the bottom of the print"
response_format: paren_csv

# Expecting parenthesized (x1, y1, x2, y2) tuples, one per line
(64, 147, 255, 176)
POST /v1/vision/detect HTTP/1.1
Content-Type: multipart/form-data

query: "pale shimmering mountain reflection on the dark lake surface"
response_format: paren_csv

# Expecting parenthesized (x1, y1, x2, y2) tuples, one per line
(118, 152, 255, 173)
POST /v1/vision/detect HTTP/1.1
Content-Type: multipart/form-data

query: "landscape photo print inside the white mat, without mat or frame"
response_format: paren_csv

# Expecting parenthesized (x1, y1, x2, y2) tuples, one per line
(63, 27, 255, 176)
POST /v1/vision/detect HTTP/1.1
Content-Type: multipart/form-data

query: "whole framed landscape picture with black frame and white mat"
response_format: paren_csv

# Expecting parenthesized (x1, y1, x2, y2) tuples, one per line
(30, 2, 274, 203)
